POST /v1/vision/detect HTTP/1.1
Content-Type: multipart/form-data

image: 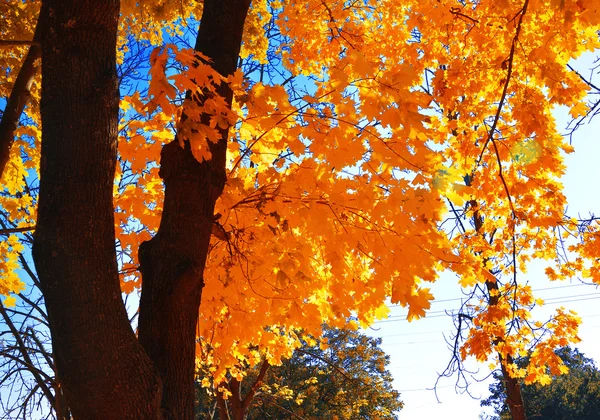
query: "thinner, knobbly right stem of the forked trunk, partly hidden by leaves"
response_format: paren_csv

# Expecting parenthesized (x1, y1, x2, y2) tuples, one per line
(138, 0, 250, 420)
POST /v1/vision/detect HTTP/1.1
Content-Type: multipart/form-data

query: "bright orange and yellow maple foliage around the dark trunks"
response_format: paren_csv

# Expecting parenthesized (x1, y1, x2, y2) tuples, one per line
(0, 0, 600, 416)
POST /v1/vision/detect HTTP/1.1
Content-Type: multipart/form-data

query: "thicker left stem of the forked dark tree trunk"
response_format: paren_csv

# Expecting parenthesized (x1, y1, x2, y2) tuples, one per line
(33, 0, 163, 420)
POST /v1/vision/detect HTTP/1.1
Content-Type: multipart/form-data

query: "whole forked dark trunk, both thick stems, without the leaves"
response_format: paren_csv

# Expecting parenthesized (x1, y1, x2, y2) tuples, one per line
(33, 0, 250, 420)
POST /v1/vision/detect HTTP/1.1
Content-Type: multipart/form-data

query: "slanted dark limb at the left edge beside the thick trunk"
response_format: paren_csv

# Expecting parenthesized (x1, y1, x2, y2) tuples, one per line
(0, 19, 42, 178)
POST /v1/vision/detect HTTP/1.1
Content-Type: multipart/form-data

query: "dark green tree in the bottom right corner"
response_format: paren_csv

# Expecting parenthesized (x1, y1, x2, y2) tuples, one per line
(481, 347, 600, 420)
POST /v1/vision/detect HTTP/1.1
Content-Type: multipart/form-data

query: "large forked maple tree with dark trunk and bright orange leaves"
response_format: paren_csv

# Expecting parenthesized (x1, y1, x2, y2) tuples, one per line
(0, 0, 600, 419)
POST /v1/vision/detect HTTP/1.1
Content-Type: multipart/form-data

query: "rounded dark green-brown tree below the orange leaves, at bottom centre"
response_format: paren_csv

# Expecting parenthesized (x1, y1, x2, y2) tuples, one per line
(197, 329, 403, 419)
